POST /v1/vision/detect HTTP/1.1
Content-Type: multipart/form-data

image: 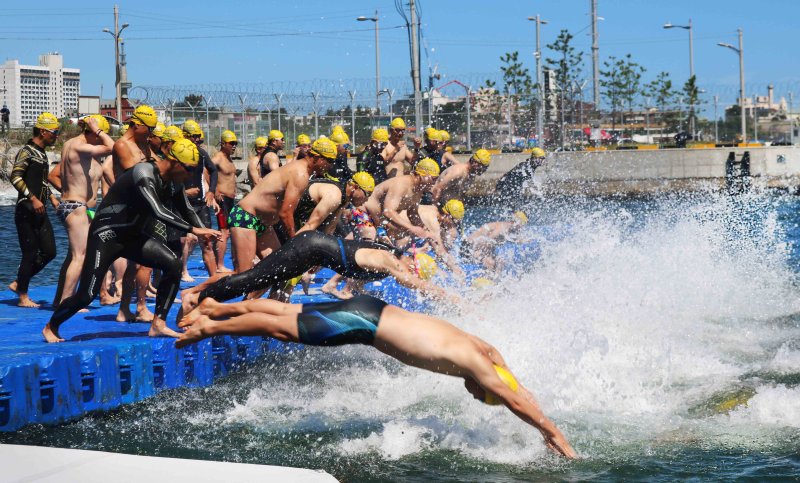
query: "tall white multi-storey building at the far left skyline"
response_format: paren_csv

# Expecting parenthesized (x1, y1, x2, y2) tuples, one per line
(0, 52, 81, 127)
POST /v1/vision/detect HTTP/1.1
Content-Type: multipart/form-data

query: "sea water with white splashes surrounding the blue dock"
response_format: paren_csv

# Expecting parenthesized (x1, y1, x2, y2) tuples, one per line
(0, 194, 800, 481)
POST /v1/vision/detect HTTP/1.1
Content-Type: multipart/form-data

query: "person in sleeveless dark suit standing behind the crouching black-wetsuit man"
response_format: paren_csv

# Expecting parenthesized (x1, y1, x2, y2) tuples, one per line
(182, 119, 219, 282)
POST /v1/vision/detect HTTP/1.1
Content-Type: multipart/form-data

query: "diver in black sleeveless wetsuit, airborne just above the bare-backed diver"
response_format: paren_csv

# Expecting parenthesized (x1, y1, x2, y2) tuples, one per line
(181, 230, 461, 313)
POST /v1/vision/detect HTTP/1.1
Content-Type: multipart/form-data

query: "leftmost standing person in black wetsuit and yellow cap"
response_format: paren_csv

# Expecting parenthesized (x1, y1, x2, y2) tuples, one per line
(8, 112, 58, 308)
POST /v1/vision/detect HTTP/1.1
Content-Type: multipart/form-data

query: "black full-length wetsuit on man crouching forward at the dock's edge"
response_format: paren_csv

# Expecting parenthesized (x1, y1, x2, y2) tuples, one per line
(50, 162, 203, 330)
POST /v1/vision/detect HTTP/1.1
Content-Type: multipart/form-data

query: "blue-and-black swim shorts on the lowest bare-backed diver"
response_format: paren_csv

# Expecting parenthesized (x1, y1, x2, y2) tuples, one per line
(297, 295, 388, 346)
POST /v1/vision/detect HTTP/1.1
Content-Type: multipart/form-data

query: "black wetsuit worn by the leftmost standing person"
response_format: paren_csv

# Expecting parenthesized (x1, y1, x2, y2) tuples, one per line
(11, 140, 56, 294)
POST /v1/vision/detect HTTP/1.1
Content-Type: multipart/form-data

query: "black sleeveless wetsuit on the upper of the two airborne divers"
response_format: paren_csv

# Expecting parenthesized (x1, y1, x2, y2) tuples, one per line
(199, 230, 402, 301)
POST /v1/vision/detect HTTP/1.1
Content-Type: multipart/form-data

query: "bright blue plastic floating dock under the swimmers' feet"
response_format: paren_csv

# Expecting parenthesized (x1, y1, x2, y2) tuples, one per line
(0, 244, 500, 432)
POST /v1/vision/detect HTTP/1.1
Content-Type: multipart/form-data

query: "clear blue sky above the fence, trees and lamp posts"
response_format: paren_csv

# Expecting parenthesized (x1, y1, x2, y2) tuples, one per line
(0, 0, 800, 109)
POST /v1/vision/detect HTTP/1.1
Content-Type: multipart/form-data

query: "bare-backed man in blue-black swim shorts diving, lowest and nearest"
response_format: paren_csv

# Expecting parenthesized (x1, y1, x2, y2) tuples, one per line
(175, 295, 577, 458)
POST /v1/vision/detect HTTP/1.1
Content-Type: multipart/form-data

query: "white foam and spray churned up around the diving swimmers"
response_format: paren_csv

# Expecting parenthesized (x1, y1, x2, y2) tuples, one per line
(226, 193, 800, 464)
